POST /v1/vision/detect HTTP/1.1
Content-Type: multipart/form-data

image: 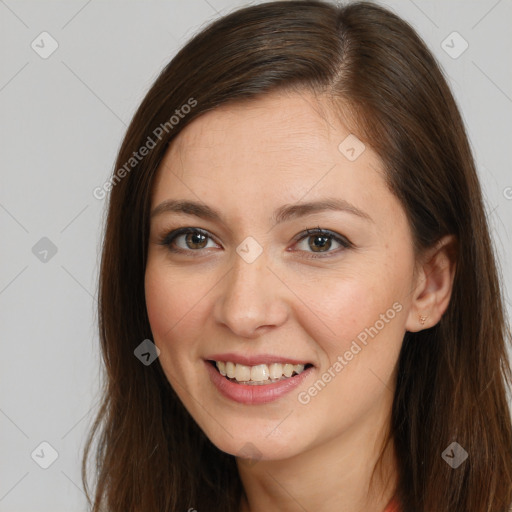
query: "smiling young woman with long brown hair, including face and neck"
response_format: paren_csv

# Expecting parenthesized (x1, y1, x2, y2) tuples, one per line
(83, 1, 512, 512)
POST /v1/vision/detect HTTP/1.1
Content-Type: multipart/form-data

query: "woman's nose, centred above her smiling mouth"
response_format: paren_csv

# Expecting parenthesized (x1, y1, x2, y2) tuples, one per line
(214, 246, 289, 338)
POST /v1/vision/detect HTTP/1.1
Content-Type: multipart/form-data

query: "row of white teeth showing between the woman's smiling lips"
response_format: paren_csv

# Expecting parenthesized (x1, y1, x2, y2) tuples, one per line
(208, 360, 313, 386)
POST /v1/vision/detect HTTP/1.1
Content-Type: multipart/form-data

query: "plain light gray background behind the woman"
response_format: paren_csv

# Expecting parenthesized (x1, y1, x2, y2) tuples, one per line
(0, 0, 512, 512)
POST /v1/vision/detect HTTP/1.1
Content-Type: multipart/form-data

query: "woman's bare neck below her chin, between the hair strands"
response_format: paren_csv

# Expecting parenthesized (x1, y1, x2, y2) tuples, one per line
(237, 402, 398, 512)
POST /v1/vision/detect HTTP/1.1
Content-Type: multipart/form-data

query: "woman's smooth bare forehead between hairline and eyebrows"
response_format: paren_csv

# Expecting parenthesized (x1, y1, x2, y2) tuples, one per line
(152, 92, 393, 230)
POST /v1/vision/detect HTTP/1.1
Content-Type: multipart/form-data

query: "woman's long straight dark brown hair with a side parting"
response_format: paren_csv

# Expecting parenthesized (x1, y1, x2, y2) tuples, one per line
(82, 1, 512, 512)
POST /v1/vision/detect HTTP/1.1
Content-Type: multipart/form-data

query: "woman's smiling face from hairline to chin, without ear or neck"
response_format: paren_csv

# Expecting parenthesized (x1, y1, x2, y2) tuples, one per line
(145, 92, 415, 460)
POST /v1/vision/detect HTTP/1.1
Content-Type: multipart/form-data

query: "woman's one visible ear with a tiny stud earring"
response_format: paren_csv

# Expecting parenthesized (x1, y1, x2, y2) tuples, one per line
(405, 235, 457, 332)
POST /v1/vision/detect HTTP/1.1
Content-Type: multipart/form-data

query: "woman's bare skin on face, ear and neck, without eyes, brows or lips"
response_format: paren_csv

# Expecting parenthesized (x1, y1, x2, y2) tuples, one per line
(145, 92, 454, 512)
